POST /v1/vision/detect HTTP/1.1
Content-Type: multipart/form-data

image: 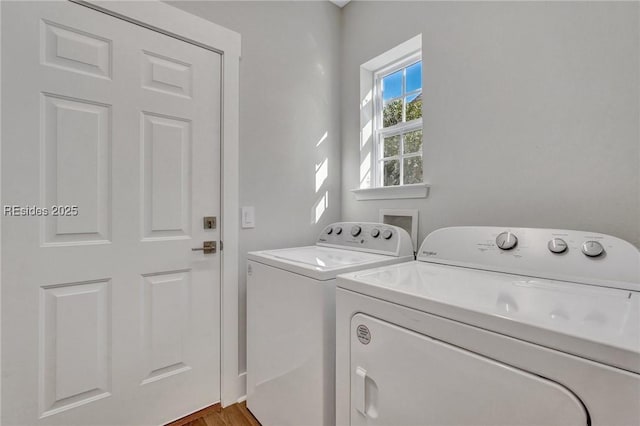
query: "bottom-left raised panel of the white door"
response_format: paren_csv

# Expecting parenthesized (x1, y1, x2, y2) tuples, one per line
(40, 281, 112, 416)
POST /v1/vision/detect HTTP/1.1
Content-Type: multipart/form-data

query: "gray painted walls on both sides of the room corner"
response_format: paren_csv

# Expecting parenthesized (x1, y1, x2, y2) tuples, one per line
(171, 1, 640, 380)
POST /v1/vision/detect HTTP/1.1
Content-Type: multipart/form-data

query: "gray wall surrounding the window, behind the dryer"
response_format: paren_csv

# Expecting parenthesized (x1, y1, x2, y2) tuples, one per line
(342, 2, 640, 245)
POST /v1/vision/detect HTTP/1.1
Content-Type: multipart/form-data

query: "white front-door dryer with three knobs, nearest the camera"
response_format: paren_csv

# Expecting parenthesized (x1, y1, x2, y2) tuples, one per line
(336, 227, 640, 426)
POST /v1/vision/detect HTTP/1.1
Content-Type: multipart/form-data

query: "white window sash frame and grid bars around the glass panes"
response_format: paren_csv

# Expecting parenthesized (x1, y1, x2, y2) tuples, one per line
(373, 51, 424, 188)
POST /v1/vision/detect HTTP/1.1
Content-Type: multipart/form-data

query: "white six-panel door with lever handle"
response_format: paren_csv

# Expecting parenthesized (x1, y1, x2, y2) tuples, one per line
(1, 1, 221, 426)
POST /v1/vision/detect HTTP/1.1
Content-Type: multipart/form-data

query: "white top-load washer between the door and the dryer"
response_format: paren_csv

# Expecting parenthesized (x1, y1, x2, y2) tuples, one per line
(247, 222, 414, 426)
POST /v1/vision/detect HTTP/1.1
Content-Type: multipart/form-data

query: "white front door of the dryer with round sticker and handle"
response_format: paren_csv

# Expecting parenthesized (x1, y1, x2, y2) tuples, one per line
(351, 314, 588, 426)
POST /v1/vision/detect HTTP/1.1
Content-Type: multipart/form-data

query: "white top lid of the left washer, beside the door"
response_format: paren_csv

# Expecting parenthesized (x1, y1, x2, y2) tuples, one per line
(247, 246, 413, 281)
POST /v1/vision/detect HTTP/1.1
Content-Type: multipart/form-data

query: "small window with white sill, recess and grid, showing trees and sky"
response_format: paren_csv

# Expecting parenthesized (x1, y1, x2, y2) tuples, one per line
(351, 34, 430, 200)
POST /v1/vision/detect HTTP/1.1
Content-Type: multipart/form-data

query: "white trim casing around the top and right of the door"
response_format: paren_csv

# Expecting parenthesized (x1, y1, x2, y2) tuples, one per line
(0, 0, 246, 412)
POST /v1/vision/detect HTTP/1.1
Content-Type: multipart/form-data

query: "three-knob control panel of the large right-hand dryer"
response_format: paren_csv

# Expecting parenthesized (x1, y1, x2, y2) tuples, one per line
(418, 226, 640, 291)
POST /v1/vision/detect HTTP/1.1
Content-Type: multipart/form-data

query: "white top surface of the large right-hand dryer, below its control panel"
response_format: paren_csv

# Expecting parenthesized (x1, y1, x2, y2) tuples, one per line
(337, 262, 640, 373)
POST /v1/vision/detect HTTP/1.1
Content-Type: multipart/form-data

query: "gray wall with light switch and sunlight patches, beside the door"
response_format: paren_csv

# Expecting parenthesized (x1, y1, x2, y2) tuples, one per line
(170, 2, 340, 371)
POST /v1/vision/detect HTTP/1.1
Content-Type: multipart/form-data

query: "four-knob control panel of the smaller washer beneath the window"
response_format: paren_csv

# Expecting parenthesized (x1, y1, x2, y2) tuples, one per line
(316, 222, 413, 256)
